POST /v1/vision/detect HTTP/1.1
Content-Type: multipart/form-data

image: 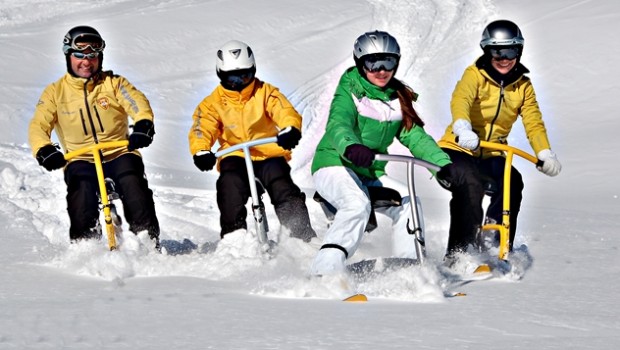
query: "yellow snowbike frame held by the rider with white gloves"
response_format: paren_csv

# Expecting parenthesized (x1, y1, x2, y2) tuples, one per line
(480, 141, 538, 260)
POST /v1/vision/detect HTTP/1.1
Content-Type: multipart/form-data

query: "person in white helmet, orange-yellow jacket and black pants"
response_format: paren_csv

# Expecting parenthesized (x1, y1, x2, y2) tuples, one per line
(188, 40, 316, 242)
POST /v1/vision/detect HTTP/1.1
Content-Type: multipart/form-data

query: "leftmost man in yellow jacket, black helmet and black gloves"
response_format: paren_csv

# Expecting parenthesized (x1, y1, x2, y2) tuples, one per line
(29, 26, 159, 248)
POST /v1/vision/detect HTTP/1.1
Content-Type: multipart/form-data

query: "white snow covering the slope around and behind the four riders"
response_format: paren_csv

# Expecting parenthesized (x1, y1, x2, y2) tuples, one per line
(0, 0, 620, 349)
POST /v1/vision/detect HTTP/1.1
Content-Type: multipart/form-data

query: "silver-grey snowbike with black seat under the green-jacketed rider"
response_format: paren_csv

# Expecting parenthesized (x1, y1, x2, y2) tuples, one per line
(313, 154, 440, 274)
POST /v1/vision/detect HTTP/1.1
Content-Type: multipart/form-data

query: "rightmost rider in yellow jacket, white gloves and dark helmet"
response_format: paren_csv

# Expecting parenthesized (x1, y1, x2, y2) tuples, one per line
(437, 20, 562, 260)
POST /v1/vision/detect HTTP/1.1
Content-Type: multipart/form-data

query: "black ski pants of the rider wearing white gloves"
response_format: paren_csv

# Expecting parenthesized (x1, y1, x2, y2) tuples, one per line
(444, 149, 523, 254)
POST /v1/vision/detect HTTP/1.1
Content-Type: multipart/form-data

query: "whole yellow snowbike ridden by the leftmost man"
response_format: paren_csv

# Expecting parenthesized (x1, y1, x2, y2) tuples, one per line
(65, 140, 129, 250)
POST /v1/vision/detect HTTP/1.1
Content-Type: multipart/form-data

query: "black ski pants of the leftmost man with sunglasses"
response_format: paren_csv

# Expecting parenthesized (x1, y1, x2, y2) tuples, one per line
(65, 153, 159, 240)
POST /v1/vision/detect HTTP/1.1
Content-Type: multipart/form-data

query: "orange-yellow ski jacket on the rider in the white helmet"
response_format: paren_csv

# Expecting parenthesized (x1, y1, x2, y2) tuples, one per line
(189, 78, 301, 167)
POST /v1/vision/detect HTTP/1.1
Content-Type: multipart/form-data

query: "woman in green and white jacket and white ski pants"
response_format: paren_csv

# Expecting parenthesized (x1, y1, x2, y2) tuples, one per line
(310, 31, 451, 276)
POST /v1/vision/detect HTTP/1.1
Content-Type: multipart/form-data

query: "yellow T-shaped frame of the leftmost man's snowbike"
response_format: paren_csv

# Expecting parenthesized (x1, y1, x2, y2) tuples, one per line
(65, 140, 129, 250)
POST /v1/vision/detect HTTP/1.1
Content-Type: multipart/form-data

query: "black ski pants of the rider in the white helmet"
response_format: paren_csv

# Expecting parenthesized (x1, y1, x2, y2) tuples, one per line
(216, 156, 316, 241)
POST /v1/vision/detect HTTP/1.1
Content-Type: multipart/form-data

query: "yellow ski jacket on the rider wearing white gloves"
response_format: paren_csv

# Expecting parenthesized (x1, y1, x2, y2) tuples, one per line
(437, 60, 550, 158)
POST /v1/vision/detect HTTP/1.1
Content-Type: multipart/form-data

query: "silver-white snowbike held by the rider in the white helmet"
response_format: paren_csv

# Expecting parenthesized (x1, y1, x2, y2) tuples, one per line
(215, 127, 290, 252)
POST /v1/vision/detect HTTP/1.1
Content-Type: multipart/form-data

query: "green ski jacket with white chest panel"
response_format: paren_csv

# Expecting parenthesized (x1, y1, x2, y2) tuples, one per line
(311, 67, 451, 179)
